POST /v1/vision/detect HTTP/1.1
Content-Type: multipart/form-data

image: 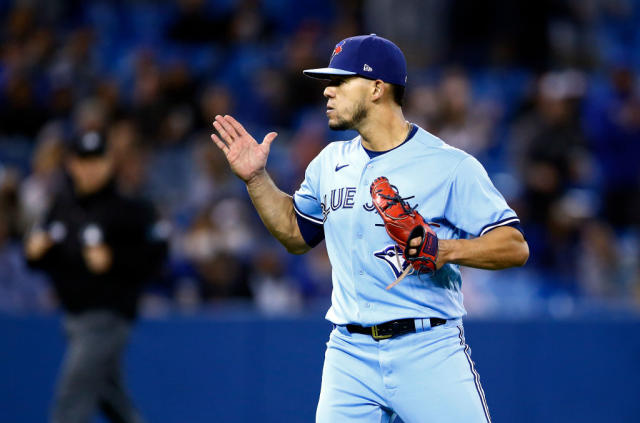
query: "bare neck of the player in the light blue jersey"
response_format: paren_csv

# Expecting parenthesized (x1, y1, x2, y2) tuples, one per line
(358, 107, 411, 151)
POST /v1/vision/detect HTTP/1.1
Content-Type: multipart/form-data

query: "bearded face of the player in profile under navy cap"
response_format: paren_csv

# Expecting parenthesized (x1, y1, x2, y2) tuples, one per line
(324, 76, 371, 130)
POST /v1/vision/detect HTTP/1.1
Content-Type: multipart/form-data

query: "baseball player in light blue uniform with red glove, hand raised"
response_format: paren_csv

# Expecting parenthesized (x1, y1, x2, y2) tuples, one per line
(212, 34, 529, 423)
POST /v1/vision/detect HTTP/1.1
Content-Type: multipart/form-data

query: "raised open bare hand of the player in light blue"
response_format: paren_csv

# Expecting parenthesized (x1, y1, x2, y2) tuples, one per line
(211, 115, 278, 182)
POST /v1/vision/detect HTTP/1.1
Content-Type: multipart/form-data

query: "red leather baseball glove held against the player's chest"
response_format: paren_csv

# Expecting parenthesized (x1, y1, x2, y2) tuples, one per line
(371, 176, 438, 289)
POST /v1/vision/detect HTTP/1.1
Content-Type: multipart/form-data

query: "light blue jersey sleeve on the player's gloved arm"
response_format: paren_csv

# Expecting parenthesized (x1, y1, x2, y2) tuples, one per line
(445, 156, 522, 236)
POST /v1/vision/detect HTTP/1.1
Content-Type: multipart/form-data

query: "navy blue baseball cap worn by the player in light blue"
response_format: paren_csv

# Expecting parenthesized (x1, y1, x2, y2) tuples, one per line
(302, 34, 407, 87)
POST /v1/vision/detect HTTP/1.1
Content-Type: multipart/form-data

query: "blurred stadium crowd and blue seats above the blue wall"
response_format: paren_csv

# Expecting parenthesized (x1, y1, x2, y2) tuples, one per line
(0, 0, 640, 314)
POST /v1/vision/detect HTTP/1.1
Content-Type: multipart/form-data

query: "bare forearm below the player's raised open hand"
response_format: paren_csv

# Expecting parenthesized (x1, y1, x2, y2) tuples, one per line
(246, 171, 311, 254)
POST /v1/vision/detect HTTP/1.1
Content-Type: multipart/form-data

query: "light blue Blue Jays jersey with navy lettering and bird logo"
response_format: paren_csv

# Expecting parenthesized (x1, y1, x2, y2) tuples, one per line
(293, 125, 519, 326)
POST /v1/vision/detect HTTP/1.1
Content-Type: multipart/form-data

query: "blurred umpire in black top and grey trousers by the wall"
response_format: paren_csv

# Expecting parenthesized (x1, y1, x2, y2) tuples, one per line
(25, 132, 167, 423)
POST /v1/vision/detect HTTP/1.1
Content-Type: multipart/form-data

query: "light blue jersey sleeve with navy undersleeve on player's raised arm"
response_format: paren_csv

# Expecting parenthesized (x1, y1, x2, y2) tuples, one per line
(293, 157, 324, 247)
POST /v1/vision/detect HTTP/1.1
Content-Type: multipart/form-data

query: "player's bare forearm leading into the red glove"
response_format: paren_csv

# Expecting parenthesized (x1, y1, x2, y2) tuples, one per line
(438, 226, 529, 270)
